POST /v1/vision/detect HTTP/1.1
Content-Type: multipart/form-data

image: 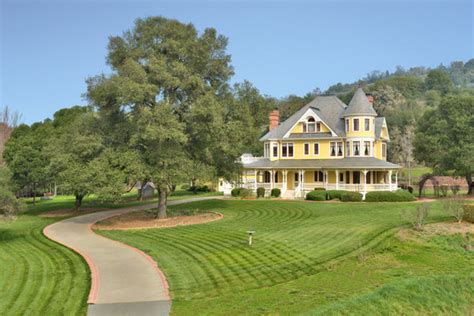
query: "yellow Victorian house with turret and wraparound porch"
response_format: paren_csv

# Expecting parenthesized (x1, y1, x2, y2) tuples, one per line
(223, 88, 400, 198)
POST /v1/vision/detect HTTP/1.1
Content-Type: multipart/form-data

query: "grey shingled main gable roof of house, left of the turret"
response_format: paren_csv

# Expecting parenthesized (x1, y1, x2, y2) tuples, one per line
(260, 96, 346, 141)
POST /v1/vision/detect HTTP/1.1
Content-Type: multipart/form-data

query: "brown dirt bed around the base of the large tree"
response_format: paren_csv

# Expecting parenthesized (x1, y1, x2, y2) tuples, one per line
(93, 211, 224, 230)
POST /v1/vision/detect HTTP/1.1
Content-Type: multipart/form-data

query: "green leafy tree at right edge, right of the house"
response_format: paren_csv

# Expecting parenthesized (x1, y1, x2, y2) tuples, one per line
(414, 96, 474, 194)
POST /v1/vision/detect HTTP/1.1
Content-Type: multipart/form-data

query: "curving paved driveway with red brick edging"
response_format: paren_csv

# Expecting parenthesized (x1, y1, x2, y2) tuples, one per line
(44, 197, 219, 315)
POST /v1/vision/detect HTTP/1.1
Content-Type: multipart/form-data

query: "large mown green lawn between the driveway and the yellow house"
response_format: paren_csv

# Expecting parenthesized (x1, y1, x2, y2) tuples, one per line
(100, 200, 474, 315)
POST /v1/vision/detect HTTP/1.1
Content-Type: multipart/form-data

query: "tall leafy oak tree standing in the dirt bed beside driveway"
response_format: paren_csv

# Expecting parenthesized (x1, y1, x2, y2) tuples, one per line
(87, 17, 238, 218)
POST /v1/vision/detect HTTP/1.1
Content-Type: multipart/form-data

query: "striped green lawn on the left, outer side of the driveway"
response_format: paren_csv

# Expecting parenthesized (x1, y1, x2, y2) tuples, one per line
(0, 192, 216, 315)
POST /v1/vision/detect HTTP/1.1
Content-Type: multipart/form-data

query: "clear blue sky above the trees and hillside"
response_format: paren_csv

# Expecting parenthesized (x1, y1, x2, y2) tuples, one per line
(0, 0, 474, 123)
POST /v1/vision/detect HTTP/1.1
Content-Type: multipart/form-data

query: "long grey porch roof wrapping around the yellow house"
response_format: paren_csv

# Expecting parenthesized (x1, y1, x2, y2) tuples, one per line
(244, 157, 401, 169)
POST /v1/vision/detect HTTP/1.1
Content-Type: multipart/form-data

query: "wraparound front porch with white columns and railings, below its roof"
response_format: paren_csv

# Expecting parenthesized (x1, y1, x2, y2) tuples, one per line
(241, 169, 398, 198)
